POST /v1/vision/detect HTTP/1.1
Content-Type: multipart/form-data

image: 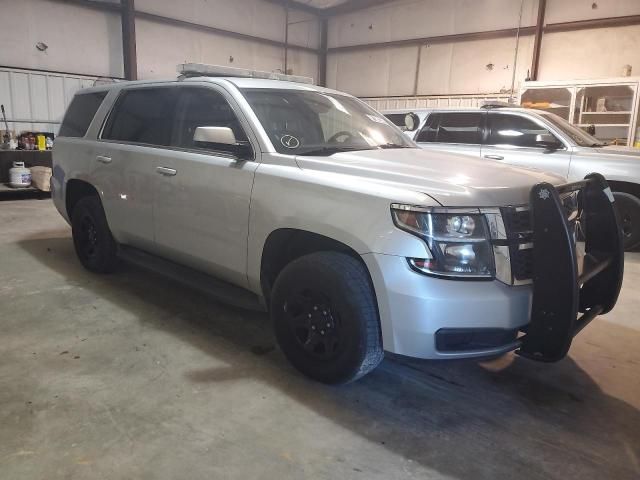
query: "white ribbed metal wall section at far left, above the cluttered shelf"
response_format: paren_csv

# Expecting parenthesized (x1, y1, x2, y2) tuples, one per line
(0, 68, 108, 134)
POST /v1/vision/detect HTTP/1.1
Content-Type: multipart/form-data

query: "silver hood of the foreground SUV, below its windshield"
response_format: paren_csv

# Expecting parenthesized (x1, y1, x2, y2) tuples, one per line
(296, 148, 565, 207)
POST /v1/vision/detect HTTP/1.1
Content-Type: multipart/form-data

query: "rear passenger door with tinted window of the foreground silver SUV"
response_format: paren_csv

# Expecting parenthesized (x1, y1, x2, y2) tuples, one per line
(95, 84, 177, 251)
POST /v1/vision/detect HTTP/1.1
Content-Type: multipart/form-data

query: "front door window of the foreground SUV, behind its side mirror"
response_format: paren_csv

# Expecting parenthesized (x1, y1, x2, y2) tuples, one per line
(172, 88, 248, 152)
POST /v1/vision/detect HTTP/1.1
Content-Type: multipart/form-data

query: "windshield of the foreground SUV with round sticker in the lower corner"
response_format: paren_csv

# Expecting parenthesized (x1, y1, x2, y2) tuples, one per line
(242, 89, 417, 156)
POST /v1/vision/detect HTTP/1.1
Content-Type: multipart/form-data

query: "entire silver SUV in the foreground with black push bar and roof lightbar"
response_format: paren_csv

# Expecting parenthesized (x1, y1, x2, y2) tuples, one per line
(52, 65, 623, 383)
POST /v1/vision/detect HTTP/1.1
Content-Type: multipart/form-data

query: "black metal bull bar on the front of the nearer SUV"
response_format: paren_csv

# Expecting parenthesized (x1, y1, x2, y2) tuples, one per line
(516, 173, 624, 362)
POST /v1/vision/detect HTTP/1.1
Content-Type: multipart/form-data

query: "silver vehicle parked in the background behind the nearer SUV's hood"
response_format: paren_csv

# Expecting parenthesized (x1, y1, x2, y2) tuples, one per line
(382, 104, 640, 250)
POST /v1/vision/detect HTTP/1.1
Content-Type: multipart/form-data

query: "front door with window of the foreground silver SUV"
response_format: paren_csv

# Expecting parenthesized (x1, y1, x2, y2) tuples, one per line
(154, 86, 258, 286)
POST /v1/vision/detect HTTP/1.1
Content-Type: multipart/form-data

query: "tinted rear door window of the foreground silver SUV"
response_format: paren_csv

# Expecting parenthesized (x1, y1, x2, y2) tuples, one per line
(102, 87, 178, 146)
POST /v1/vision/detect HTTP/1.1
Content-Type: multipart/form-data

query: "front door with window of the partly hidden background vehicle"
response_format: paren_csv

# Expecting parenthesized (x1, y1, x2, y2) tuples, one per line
(482, 110, 571, 177)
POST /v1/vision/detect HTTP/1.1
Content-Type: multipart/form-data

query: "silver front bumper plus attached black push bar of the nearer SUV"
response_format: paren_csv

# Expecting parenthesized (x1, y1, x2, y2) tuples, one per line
(362, 174, 624, 362)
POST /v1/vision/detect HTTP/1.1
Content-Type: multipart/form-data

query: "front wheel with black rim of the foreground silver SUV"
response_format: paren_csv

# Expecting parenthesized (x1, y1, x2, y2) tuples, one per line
(270, 252, 384, 384)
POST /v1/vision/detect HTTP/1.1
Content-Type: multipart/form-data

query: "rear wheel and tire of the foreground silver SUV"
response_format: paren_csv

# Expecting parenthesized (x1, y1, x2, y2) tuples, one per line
(71, 196, 118, 273)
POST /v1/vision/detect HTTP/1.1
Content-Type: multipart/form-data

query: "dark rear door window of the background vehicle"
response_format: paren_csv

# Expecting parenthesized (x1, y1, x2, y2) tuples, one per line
(416, 112, 484, 144)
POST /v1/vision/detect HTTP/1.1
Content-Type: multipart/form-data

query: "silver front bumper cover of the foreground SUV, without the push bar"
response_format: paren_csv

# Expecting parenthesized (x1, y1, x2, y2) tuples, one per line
(362, 253, 532, 359)
